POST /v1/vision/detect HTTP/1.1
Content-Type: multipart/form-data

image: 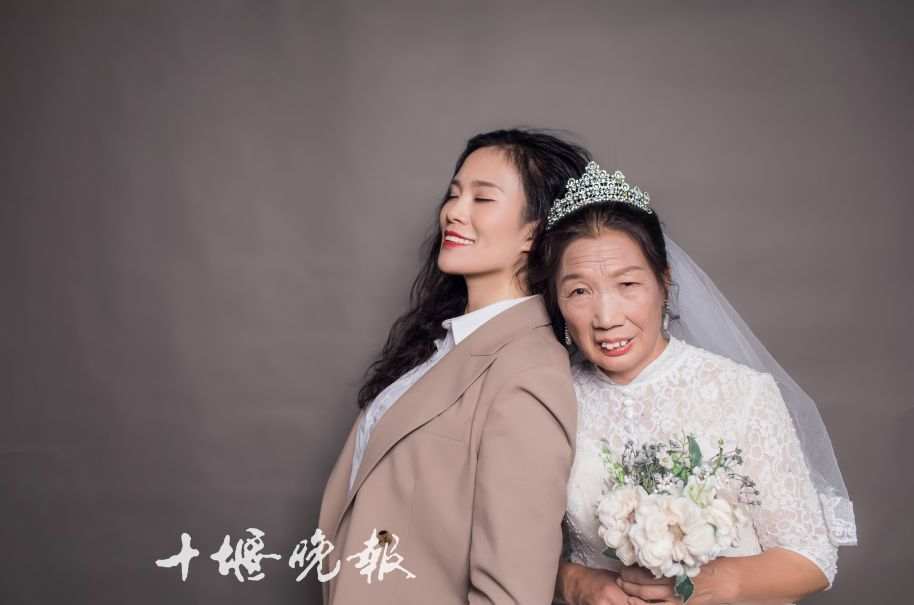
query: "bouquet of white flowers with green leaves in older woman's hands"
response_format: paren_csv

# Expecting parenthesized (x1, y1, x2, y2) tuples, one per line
(596, 435, 759, 602)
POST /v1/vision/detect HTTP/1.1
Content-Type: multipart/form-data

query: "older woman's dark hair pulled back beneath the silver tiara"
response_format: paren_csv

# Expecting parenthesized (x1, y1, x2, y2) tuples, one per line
(527, 202, 677, 342)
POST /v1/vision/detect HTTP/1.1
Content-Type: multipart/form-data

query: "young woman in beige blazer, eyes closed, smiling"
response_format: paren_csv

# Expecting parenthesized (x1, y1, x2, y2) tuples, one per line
(319, 130, 589, 605)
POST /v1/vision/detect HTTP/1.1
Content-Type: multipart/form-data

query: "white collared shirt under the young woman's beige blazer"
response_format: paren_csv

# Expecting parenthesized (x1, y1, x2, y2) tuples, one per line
(349, 294, 536, 490)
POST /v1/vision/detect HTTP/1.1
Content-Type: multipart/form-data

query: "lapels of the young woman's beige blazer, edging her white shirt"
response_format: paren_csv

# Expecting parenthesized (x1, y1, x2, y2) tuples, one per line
(321, 295, 551, 537)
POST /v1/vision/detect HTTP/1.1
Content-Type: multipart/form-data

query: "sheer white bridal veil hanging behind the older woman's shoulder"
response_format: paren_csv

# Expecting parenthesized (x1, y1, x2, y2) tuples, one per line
(664, 236, 857, 546)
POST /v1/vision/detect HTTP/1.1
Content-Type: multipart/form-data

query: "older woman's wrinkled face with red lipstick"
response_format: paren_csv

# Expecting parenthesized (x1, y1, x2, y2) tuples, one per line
(557, 229, 667, 384)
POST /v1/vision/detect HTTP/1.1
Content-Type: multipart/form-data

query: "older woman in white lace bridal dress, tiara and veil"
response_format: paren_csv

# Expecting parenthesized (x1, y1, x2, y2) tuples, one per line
(531, 163, 856, 605)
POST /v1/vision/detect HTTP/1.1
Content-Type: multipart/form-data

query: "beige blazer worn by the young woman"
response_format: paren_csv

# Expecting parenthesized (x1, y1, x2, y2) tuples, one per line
(318, 296, 577, 605)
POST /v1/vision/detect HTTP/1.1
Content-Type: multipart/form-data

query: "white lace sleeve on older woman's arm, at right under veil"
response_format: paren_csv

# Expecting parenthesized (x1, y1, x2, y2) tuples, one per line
(742, 374, 838, 588)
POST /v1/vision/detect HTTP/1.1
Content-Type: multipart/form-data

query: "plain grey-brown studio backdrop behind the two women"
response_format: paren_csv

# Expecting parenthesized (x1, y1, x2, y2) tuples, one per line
(0, 0, 914, 604)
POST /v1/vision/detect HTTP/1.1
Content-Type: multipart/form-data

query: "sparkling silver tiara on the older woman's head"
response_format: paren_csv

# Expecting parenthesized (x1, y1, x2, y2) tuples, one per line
(546, 161, 654, 229)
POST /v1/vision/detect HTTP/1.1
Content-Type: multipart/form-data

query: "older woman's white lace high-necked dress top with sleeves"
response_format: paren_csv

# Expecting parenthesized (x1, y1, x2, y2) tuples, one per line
(565, 338, 838, 586)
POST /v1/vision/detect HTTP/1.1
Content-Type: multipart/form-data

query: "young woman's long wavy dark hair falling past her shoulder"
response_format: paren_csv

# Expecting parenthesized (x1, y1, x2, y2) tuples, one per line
(358, 128, 591, 408)
